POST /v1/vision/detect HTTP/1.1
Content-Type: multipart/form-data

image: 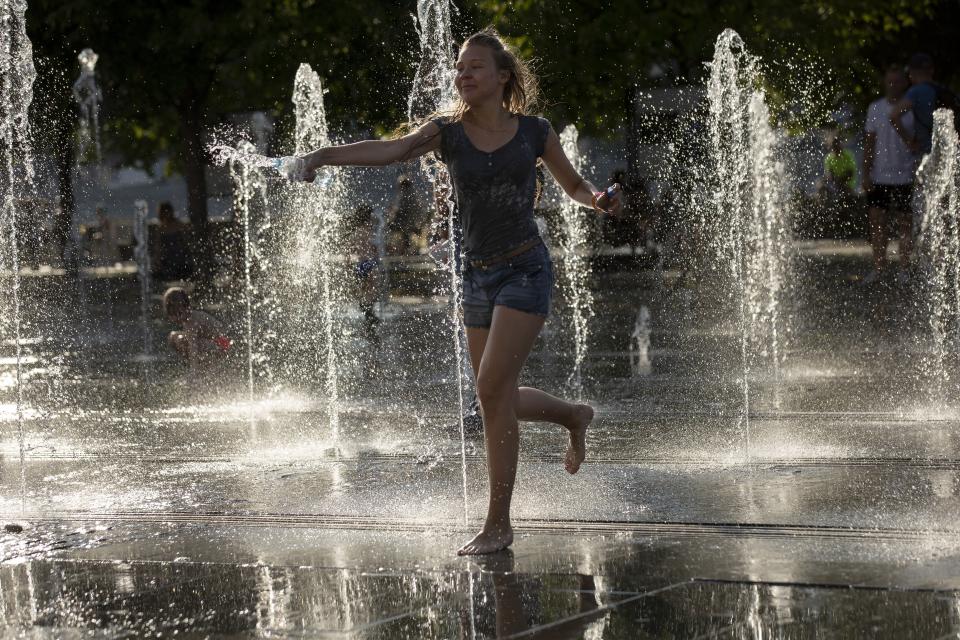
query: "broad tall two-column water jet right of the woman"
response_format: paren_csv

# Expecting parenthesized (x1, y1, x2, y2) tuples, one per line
(701, 29, 789, 458)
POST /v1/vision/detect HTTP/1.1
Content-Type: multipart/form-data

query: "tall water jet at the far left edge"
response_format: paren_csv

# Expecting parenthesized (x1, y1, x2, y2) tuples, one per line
(0, 0, 37, 508)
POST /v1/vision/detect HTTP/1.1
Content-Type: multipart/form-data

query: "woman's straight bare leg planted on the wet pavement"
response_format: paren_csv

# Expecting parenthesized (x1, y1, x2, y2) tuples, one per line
(457, 306, 544, 555)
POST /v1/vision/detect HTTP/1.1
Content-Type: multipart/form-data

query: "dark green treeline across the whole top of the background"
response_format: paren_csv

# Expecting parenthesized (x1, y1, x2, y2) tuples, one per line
(27, 0, 960, 248)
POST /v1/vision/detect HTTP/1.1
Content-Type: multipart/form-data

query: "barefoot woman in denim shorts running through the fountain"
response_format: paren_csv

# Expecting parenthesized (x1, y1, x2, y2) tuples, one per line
(294, 29, 622, 555)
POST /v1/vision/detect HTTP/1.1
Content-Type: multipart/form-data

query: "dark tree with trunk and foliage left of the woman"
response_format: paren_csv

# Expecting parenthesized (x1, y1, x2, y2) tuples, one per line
(28, 0, 415, 272)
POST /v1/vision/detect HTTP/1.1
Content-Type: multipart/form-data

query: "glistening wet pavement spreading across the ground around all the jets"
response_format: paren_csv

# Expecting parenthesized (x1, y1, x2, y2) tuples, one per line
(0, 246, 960, 638)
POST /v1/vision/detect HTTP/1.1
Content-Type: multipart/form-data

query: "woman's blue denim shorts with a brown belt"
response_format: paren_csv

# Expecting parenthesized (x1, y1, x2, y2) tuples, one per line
(463, 242, 554, 329)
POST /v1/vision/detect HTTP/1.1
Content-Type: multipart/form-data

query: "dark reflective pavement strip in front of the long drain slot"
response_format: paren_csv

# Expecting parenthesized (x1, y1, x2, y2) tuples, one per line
(0, 525, 960, 639)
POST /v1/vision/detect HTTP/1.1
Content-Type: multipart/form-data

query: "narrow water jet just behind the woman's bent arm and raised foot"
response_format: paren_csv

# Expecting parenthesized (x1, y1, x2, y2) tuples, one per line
(559, 124, 594, 402)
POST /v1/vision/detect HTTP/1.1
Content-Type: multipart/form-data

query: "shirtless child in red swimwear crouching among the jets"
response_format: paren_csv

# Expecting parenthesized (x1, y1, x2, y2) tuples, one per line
(163, 287, 233, 369)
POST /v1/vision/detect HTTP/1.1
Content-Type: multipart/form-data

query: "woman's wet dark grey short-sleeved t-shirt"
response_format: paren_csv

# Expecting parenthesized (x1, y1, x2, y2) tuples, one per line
(433, 115, 550, 260)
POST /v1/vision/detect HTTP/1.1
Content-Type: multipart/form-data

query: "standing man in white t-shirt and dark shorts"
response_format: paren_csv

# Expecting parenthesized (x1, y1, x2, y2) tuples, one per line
(863, 67, 917, 284)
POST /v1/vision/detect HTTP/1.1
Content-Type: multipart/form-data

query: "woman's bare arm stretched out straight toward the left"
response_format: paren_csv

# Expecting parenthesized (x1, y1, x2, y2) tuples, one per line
(302, 122, 440, 176)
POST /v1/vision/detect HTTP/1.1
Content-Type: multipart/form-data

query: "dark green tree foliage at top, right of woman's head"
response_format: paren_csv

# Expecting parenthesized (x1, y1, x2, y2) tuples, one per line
(464, 0, 960, 133)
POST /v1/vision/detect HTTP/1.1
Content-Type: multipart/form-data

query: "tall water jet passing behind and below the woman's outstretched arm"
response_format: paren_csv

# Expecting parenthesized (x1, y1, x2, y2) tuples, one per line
(407, 0, 470, 525)
